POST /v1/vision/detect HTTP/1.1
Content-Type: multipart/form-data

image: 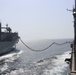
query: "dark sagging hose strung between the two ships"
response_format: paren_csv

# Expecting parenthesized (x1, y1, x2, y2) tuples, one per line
(20, 38, 72, 52)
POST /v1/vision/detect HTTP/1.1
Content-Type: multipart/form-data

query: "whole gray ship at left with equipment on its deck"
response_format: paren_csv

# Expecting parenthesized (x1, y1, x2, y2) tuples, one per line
(0, 23, 20, 56)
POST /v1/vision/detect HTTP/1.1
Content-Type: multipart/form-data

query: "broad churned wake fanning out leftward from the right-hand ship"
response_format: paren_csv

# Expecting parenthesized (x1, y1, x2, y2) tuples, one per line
(10, 51, 71, 75)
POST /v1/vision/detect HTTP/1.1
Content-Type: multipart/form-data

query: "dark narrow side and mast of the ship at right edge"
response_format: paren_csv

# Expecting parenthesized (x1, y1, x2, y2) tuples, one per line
(70, 0, 76, 75)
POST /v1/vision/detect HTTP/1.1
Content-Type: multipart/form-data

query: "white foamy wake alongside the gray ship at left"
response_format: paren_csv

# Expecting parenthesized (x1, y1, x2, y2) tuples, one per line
(0, 50, 23, 75)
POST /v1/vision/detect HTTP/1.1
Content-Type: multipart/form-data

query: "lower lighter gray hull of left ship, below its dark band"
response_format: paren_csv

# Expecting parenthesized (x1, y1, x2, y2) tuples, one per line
(0, 38, 19, 56)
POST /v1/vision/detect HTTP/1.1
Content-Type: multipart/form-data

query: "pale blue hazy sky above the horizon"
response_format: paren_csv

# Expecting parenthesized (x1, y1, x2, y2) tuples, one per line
(0, 0, 74, 40)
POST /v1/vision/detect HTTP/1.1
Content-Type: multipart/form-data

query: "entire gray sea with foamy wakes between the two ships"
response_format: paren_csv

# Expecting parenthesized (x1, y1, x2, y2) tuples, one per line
(0, 39, 72, 75)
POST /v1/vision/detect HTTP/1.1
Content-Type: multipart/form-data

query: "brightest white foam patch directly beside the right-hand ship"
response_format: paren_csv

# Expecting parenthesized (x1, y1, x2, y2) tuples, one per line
(44, 51, 71, 75)
